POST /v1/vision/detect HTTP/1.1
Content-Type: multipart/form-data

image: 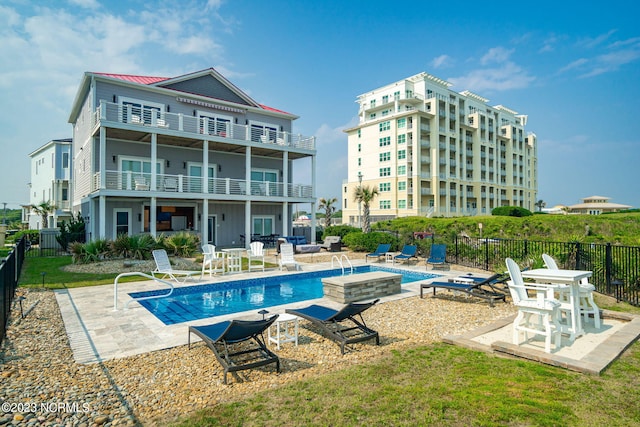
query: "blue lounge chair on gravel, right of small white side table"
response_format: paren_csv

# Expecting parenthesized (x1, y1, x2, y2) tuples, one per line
(285, 299, 380, 354)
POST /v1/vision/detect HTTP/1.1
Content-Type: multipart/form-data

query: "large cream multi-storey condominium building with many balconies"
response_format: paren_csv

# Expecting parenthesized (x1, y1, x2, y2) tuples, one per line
(342, 73, 538, 225)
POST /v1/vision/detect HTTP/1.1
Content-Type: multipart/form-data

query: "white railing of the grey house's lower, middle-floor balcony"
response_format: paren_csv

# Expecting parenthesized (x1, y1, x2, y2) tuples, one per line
(91, 171, 313, 198)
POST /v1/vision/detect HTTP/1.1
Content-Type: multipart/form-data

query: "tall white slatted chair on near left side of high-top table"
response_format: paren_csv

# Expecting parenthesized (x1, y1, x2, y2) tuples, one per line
(506, 258, 562, 353)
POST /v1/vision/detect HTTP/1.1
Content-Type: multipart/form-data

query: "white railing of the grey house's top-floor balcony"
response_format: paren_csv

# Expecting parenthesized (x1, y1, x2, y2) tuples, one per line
(93, 101, 316, 150)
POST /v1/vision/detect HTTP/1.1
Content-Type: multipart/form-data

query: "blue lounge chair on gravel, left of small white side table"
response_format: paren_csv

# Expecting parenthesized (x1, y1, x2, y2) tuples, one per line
(188, 314, 280, 384)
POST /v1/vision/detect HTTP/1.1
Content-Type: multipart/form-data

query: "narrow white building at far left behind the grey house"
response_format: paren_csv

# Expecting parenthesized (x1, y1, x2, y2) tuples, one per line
(23, 138, 72, 230)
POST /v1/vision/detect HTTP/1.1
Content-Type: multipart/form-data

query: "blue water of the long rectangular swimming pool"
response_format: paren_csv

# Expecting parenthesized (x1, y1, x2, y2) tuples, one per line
(129, 265, 438, 325)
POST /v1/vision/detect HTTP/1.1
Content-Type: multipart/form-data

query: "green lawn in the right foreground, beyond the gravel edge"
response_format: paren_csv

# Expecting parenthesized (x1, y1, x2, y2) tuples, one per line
(168, 295, 640, 427)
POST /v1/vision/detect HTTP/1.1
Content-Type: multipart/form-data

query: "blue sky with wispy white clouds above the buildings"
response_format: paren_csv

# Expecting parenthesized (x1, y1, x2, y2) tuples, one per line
(0, 0, 640, 211)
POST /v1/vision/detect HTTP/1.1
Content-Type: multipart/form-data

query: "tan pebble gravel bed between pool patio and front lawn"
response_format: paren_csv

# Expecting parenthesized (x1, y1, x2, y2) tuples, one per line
(0, 256, 515, 426)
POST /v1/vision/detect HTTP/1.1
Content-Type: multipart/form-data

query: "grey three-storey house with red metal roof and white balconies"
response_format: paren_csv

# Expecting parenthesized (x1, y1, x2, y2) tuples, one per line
(69, 69, 316, 246)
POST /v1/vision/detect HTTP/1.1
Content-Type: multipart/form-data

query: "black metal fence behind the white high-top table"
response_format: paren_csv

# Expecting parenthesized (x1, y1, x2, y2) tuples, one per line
(447, 237, 640, 306)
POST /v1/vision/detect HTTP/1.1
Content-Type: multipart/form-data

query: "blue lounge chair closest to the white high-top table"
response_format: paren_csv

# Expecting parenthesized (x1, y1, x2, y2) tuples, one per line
(420, 273, 509, 307)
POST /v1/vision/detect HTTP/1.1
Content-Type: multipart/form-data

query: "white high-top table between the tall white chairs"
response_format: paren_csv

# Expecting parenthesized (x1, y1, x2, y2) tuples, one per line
(522, 268, 592, 342)
